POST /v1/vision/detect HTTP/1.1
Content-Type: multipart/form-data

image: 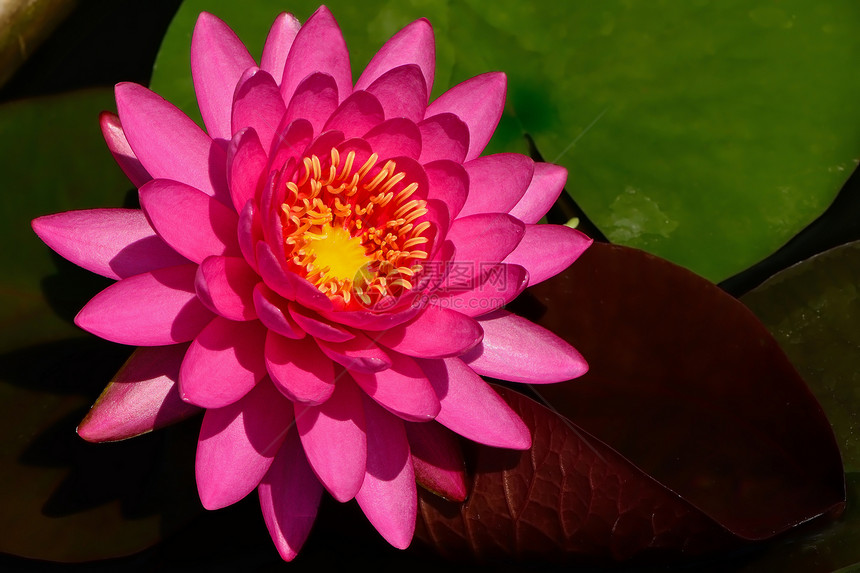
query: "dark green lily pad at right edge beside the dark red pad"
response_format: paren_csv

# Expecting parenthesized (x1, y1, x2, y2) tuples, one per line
(741, 242, 860, 472)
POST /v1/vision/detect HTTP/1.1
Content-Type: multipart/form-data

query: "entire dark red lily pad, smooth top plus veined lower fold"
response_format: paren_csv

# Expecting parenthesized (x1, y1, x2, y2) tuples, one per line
(421, 244, 845, 559)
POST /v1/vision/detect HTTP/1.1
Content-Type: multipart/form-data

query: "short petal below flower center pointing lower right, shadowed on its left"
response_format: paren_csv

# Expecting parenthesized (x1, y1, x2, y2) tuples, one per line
(351, 350, 439, 422)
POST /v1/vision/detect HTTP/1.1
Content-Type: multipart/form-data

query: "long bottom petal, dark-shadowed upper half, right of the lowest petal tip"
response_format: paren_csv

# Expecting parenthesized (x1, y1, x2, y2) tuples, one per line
(355, 398, 418, 549)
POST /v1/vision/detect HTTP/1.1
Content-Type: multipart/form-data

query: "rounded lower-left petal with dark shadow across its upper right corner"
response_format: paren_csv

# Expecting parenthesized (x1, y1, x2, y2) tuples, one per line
(179, 316, 266, 408)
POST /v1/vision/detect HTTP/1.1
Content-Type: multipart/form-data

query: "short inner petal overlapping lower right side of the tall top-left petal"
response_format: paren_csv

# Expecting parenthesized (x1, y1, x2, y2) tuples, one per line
(231, 68, 287, 150)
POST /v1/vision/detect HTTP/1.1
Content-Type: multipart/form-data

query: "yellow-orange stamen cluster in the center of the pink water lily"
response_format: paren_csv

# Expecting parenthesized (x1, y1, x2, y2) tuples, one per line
(281, 148, 430, 308)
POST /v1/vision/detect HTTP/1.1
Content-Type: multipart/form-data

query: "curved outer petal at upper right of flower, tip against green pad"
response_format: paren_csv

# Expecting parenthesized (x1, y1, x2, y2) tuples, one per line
(355, 18, 436, 95)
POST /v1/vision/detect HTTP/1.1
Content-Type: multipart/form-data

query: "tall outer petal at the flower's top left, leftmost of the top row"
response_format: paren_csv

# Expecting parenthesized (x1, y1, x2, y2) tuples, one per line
(191, 12, 257, 140)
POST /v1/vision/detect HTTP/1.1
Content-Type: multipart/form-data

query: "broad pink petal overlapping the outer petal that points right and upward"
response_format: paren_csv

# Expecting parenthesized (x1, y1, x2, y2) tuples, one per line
(460, 153, 535, 217)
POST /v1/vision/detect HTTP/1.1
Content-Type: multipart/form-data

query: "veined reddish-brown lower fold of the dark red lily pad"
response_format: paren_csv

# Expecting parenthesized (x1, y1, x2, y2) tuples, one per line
(416, 388, 738, 562)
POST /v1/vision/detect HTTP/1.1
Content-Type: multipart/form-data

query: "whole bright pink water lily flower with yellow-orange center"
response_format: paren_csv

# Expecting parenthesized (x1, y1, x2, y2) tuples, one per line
(33, 7, 590, 559)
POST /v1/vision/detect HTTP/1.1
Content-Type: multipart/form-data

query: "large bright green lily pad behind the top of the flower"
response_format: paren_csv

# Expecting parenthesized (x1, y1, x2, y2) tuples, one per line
(152, 0, 860, 281)
